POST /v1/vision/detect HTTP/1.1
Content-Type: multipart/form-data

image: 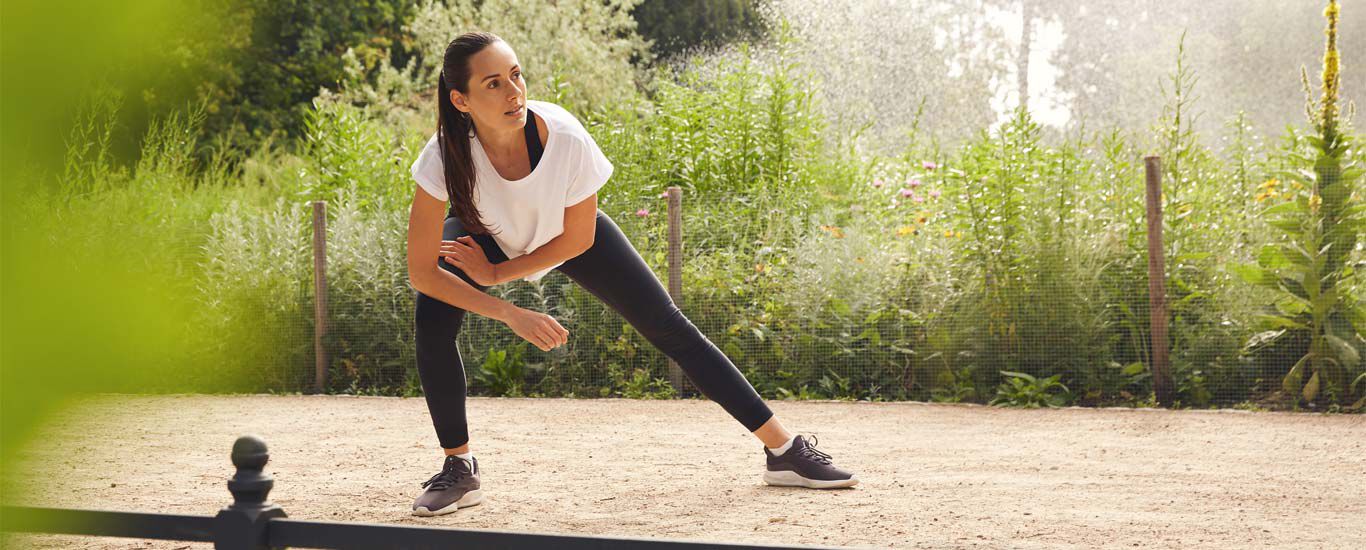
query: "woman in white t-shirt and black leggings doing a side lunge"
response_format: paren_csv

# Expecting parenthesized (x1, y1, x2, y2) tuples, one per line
(408, 33, 858, 516)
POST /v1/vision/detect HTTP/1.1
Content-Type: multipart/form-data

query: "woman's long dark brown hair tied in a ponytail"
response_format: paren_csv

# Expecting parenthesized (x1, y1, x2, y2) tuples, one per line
(436, 31, 503, 235)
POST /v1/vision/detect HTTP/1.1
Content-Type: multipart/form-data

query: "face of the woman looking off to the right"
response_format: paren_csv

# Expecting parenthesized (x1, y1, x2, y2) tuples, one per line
(451, 41, 526, 128)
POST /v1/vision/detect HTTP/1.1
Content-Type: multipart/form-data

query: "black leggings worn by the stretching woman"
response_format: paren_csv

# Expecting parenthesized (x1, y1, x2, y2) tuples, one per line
(415, 210, 773, 449)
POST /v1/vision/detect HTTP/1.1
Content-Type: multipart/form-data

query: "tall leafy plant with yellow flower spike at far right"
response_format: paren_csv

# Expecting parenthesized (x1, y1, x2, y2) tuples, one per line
(1235, 3, 1366, 401)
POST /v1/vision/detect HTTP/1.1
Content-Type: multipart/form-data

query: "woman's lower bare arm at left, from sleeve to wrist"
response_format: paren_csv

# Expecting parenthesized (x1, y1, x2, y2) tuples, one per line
(408, 188, 518, 322)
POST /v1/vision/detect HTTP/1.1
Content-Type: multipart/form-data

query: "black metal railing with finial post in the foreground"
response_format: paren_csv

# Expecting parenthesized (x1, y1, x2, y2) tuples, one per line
(0, 435, 841, 550)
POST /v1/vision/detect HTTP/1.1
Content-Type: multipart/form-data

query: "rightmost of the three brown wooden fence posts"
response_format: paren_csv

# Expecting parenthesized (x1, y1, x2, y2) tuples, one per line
(1143, 154, 1173, 407)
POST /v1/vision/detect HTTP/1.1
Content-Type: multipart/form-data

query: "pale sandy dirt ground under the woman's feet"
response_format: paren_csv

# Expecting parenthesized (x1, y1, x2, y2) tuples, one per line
(0, 394, 1366, 549)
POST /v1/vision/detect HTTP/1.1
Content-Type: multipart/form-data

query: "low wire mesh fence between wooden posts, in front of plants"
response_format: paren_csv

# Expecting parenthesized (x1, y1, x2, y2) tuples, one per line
(187, 156, 1359, 407)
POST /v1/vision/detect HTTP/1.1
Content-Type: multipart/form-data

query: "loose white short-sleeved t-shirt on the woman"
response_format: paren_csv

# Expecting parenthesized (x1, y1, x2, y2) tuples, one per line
(411, 100, 612, 281)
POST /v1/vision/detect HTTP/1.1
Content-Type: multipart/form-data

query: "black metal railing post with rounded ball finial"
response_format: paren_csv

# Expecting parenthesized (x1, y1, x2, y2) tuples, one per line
(213, 435, 285, 550)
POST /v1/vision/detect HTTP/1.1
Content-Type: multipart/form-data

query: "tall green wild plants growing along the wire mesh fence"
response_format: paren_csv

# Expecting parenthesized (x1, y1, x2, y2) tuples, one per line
(37, 8, 1363, 407)
